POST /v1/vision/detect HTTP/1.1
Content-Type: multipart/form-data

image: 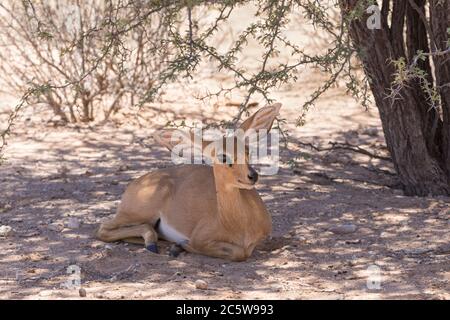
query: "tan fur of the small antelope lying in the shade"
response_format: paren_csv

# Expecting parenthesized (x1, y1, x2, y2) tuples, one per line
(97, 104, 281, 261)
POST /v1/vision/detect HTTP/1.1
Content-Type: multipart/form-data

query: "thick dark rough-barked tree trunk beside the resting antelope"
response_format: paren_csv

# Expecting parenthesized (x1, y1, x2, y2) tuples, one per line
(340, 0, 450, 196)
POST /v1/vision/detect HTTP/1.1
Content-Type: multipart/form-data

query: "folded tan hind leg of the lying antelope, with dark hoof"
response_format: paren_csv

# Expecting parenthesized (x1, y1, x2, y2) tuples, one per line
(97, 219, 158, 253)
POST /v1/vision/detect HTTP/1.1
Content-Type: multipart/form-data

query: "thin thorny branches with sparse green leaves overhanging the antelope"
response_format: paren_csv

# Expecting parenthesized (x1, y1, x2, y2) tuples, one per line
(0, 0, 370, 160)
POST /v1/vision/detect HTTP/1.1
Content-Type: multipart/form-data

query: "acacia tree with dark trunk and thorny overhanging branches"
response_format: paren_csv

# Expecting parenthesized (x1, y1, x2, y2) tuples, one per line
(0, 0, 450, 196)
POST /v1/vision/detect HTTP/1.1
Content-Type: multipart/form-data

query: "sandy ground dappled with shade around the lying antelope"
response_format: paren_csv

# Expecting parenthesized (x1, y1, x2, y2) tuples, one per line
(0, 5, 450, 299)
